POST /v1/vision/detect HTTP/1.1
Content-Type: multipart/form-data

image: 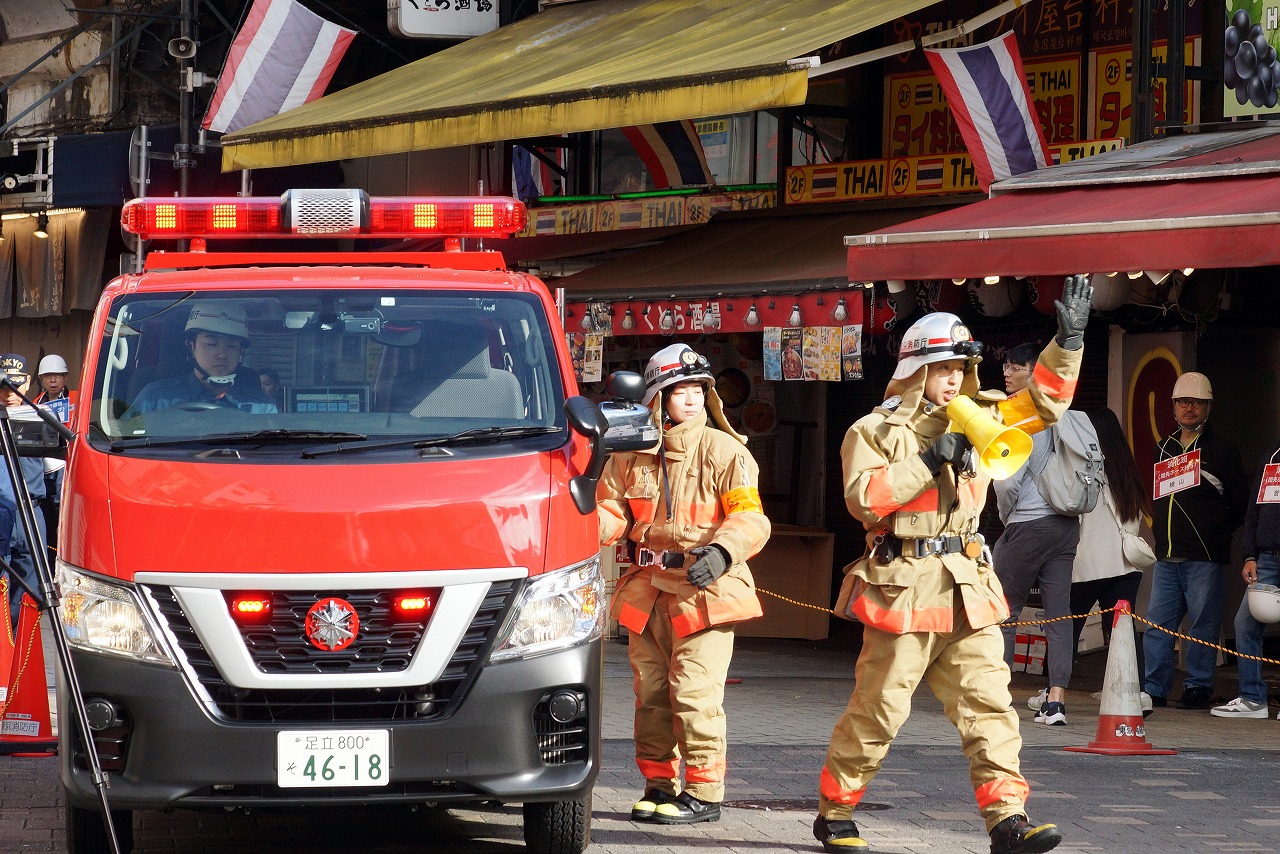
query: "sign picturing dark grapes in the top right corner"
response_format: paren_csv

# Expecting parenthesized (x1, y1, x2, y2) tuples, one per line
(1206, 0, 1280, 119)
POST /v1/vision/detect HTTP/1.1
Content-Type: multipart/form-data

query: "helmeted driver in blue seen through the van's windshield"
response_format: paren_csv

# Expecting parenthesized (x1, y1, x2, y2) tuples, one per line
(125, 302, 279, 417)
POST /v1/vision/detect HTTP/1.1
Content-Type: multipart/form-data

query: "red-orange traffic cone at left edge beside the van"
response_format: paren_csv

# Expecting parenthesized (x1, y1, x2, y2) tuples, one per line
(0, 595, 58, 757)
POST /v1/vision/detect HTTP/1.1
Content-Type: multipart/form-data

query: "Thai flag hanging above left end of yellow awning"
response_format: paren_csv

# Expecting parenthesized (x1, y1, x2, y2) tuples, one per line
(202, 0, 356, 133)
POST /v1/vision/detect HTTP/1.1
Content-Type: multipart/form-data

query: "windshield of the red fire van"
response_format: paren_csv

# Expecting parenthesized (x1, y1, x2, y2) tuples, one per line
(91, 287, 564, 456)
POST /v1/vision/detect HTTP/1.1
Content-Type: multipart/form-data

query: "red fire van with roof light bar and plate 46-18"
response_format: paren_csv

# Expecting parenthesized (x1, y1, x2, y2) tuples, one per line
(55, 191, 657, 854)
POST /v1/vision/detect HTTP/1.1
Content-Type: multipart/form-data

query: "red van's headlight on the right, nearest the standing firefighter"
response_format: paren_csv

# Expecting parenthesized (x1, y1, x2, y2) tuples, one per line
(489, 557, 604, 661)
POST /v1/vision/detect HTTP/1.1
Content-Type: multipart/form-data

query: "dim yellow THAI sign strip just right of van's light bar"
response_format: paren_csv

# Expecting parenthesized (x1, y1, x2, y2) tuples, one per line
(516, 189, 778, 237)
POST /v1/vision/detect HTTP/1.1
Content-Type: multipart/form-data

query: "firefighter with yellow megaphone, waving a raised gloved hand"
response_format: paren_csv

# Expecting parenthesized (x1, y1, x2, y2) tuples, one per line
(813, 277, 1092, 854)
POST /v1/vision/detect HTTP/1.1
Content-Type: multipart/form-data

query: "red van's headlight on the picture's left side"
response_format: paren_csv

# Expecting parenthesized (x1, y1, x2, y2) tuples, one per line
(58, 561, 173, 665)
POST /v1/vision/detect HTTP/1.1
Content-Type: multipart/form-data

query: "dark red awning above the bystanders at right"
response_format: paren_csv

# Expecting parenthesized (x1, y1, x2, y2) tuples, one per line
(845, 174, 1280, 282)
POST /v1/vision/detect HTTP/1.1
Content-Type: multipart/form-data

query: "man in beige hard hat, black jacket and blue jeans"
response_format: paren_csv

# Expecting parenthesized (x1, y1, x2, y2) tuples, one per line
(1142, 371, 1247, 711)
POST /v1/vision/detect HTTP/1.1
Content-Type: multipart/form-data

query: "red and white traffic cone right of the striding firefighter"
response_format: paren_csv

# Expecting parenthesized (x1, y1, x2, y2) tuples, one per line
(1064, 600, 1178, 757)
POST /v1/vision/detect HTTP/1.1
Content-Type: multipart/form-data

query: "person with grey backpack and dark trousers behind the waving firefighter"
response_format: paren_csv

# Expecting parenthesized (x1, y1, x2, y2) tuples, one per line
(993, 343, 1102, 726)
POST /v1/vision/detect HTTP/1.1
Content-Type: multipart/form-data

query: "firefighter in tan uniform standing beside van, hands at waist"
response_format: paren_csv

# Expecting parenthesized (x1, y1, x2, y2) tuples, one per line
(596, 344, 769, 825)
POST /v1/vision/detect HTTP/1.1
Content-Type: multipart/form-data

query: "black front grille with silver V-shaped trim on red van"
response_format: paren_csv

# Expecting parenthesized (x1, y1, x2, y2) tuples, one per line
(147, 581, 518, 723)
